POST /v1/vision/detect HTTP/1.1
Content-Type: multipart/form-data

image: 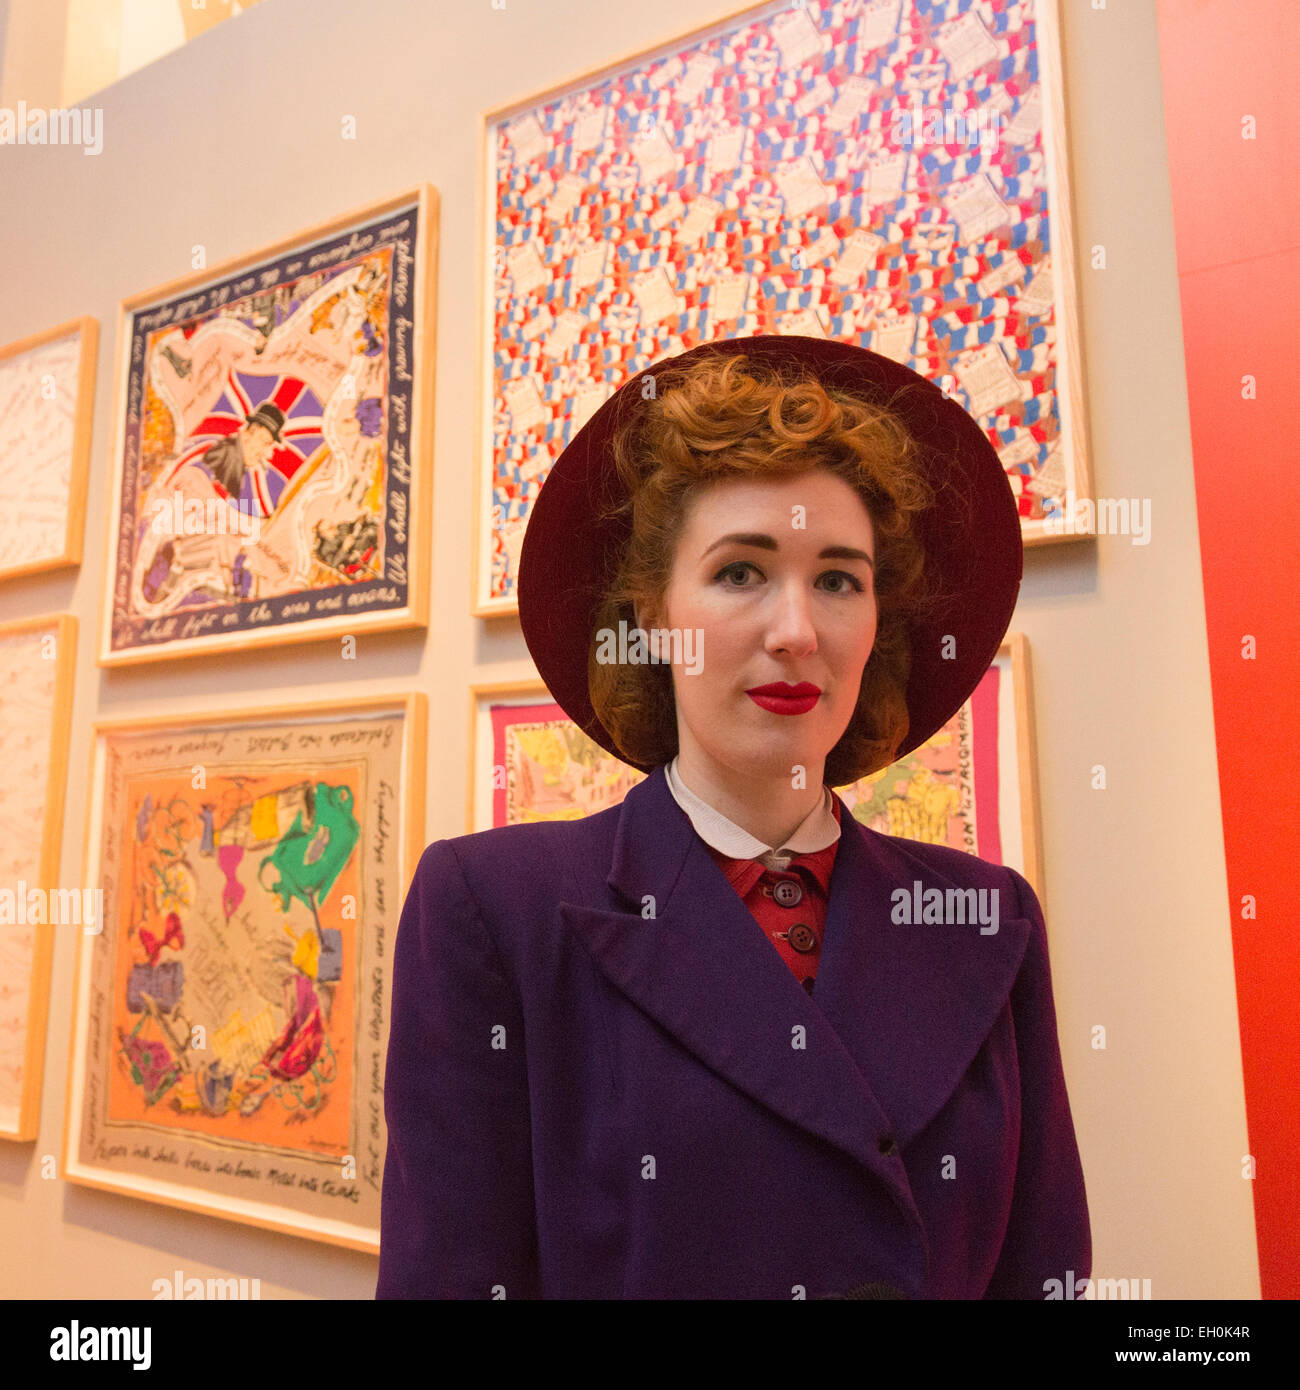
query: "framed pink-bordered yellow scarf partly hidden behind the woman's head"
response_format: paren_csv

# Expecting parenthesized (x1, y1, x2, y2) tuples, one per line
(466, 632, 1044, 897)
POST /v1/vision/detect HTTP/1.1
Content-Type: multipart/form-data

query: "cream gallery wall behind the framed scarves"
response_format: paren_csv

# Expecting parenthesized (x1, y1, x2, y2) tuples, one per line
(0, 0, 1258, 1298)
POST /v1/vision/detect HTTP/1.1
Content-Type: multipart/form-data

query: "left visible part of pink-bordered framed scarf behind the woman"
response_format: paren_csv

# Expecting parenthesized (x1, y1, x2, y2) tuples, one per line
(466, 677, 645, 833)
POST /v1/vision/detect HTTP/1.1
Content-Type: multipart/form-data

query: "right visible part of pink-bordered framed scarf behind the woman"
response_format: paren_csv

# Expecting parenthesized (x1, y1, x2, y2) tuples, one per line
(836, 632, 1043, 898)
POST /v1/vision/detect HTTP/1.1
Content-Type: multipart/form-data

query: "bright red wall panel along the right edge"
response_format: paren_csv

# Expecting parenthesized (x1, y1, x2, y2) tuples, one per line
(1158, 0, 1300, 1298)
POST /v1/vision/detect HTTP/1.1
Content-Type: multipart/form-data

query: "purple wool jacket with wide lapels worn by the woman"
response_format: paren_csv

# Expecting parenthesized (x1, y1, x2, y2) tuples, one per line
(375, 767, 1091, 1300)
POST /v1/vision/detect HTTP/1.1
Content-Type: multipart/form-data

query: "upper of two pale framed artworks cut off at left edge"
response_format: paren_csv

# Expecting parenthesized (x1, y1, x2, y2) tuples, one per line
(0, 318, 99, 580)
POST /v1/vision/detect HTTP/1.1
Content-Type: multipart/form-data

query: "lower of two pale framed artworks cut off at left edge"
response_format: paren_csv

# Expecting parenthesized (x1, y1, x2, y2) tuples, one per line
(0, 613, 81, 1140)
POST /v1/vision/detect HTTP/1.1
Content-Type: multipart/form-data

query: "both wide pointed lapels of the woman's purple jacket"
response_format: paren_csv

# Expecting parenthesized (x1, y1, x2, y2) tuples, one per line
(558, 767, 1029, 1229)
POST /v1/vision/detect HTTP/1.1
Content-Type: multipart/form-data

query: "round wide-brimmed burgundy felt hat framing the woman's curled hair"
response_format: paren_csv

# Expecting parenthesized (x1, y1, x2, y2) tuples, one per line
(519, 334, 1023, 773)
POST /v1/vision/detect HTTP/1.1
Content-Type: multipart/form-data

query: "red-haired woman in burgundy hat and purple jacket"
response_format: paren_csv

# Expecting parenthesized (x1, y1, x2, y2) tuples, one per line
(377, 336, 1090, 1298)
